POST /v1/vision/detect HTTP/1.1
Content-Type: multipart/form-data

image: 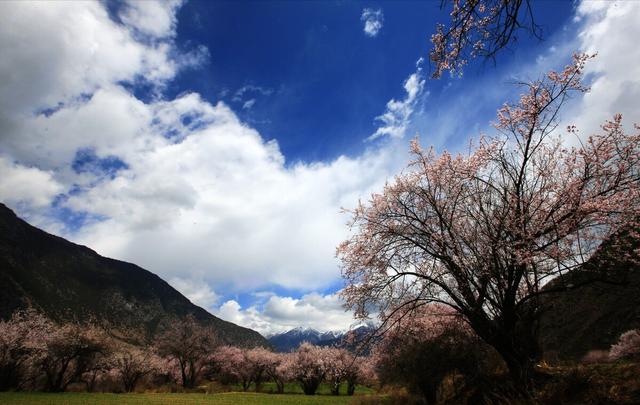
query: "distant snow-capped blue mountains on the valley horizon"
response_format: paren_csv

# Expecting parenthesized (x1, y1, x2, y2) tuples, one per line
(268, 324, 375, 352)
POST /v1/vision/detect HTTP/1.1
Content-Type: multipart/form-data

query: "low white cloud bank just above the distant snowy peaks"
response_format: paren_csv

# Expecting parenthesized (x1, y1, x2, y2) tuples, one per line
(214, 293, 354, 336)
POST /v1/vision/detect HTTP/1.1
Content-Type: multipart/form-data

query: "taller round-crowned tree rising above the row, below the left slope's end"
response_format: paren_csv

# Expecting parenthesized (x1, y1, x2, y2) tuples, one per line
(157, 315, 218, 388)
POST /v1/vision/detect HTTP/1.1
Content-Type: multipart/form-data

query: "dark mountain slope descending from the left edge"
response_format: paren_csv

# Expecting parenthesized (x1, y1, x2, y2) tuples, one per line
(0, 203, 268, 346)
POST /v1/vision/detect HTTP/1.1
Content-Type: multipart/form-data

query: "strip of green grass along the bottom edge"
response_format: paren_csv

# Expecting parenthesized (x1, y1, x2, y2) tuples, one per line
(0, 392, 370, 405)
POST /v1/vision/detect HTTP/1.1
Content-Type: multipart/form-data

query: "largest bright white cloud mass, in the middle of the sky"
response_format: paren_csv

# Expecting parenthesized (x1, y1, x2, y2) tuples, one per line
(62, 104, 392, 291)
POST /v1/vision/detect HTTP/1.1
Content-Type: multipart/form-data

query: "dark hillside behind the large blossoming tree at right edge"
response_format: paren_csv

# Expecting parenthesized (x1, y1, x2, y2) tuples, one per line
(540, 227, 640, 360)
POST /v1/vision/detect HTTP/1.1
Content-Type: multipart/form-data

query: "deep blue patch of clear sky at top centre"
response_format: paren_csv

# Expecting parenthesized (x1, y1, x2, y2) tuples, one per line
(151, 1, 573, 161)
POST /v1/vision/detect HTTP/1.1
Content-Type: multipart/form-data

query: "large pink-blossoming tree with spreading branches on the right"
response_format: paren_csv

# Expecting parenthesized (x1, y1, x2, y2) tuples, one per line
(337, 55, 640, 386)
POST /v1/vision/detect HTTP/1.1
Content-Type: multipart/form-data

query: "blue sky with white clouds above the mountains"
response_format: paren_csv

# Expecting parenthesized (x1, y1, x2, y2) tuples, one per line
(0, 0, 640, 335)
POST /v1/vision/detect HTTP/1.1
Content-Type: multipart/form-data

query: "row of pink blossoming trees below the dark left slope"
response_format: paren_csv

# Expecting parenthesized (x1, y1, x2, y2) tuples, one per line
(0, 310, 374, 395)
